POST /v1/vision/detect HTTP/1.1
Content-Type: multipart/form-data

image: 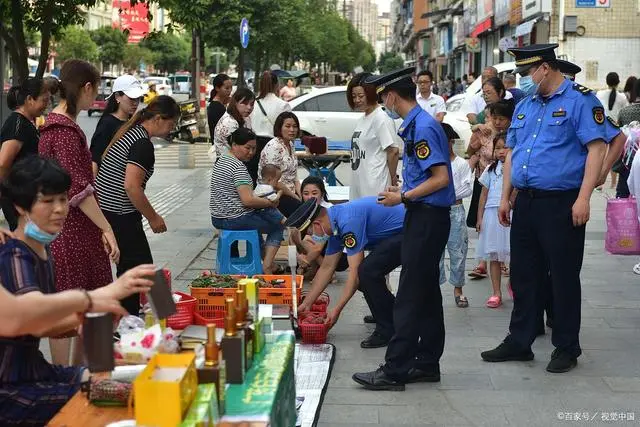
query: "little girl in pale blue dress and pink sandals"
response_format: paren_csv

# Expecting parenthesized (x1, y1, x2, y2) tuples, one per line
(476, 132, 510, 308)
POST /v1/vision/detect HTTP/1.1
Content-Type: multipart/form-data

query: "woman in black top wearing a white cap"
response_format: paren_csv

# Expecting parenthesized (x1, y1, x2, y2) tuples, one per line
(90, 74, 144, 176)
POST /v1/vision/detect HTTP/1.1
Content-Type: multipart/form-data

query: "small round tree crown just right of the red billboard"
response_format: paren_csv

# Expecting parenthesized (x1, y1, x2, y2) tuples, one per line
(140, 32, 191, 73)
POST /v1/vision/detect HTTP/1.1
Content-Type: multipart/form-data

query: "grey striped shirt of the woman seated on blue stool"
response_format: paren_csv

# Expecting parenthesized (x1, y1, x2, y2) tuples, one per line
(209, 153, 253, 219)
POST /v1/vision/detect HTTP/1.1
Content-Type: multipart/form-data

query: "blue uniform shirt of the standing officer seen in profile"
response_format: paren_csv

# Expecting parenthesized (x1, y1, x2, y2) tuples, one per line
(398, 105, 456, 207)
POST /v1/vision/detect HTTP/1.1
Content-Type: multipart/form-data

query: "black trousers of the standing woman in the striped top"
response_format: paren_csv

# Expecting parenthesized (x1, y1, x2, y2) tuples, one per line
(102, 211, 153, 316)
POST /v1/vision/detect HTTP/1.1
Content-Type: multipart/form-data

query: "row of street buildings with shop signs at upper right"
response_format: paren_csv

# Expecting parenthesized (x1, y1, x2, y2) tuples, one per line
(391, 0, 640, 88)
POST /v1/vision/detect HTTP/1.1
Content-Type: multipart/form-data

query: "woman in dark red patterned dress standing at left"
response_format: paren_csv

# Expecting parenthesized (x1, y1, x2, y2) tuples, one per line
(38, 59, 120, 364)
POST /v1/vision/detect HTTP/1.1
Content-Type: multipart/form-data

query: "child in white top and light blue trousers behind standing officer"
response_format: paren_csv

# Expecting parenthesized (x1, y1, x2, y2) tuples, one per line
(440, 123, 473, 308)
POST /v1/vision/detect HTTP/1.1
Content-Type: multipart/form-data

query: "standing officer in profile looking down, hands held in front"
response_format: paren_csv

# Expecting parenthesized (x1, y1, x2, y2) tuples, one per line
(353, 68, 455, 390)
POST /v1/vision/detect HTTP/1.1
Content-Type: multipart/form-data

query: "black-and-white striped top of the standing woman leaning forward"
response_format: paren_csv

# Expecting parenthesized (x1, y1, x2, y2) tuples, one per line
(96, 125, 155, 215)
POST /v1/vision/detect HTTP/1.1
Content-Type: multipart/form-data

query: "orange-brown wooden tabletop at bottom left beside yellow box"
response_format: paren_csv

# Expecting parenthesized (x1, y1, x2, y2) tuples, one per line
(47, 391, 134, 427)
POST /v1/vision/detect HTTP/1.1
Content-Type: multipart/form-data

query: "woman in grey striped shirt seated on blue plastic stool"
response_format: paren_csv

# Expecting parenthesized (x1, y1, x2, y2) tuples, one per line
(209, 128, 285, 274)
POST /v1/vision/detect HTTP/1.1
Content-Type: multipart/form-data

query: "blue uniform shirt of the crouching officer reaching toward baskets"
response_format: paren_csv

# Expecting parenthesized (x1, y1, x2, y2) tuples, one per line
(326, 197, 405, 256)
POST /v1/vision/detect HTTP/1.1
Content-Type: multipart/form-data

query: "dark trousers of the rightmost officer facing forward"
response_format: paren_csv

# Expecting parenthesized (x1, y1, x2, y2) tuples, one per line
(505, 190, 586, 357)
